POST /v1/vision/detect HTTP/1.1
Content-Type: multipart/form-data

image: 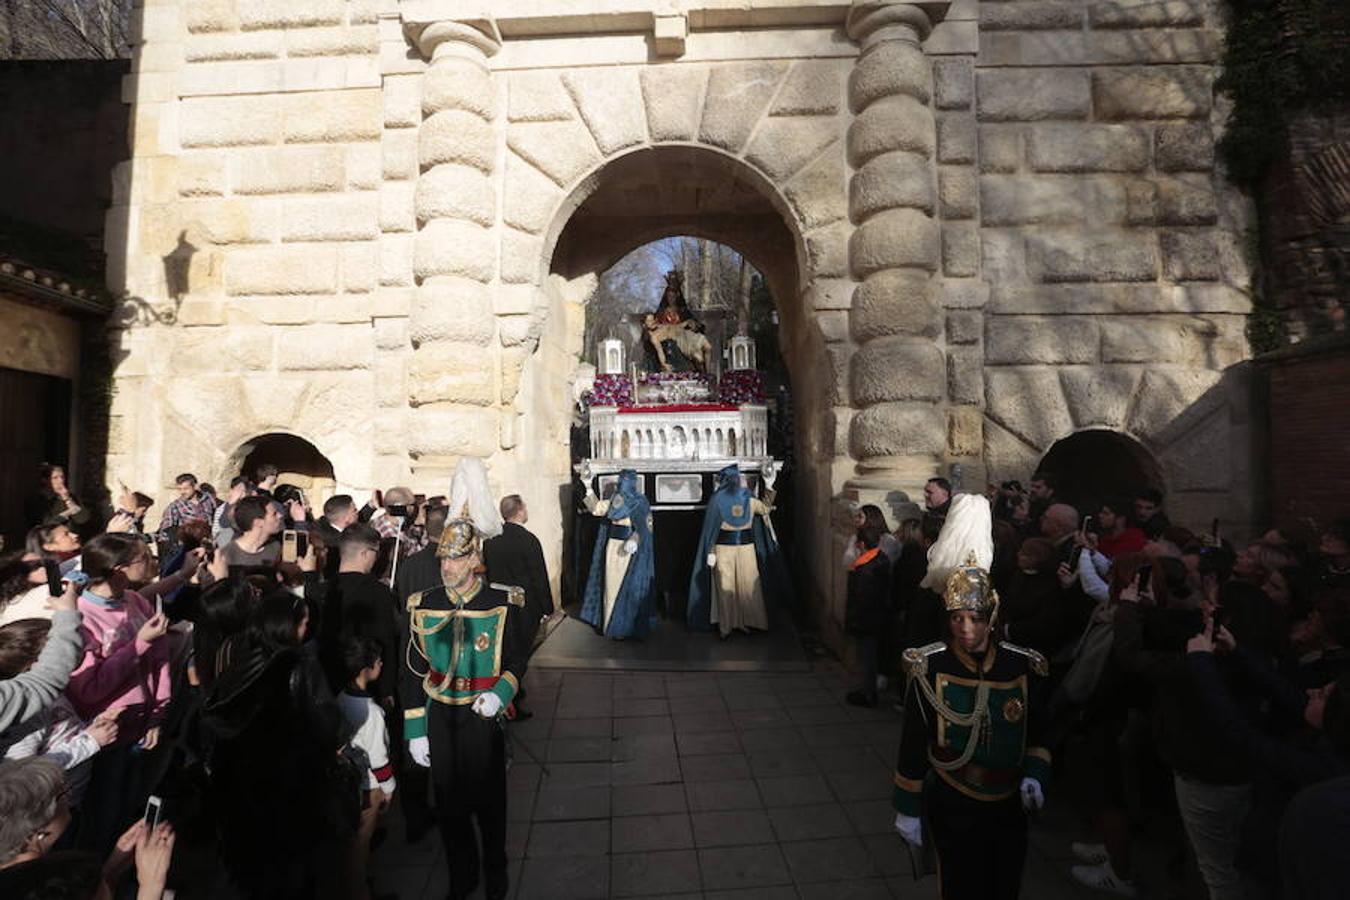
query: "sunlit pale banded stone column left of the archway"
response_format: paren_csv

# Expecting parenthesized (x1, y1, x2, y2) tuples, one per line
(405, 22, 501, 470)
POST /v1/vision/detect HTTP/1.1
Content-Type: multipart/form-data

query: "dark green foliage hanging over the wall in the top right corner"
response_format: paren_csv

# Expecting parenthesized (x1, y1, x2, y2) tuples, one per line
(1216, 0, 1350, 186)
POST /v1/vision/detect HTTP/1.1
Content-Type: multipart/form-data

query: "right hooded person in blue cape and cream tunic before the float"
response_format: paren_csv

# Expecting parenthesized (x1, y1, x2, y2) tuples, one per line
(686, 463, 791, 638)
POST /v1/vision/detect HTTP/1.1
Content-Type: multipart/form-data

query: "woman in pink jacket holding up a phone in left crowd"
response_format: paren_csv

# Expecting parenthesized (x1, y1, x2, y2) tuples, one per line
(66, 534, 173, 851)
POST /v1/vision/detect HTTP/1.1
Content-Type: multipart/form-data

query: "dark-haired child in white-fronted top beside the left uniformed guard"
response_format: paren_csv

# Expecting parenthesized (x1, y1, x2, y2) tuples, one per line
(338, 637, 396, 899)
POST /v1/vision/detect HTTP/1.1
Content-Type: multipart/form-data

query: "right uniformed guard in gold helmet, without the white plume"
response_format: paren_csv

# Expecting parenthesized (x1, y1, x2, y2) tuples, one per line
(894, 553, 1050, 900)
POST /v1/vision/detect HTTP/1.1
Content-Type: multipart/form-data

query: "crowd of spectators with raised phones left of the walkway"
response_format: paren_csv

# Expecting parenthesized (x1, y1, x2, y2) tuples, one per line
(0, 466, 552, 900)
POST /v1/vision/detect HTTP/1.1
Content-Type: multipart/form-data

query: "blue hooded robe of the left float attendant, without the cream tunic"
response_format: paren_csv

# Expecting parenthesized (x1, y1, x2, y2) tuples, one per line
(581, 468, 656, 638)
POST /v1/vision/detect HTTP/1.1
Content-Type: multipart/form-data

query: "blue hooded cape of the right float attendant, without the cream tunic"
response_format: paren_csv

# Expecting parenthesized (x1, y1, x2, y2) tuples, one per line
(686, 463, 792, 631)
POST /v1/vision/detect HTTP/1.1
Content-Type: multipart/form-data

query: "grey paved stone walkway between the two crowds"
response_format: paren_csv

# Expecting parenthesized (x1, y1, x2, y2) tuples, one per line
(375, 665, 1128, 900)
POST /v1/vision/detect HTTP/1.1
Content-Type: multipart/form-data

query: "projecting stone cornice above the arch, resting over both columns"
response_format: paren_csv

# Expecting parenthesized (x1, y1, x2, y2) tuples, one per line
(400, 0, 950, 39)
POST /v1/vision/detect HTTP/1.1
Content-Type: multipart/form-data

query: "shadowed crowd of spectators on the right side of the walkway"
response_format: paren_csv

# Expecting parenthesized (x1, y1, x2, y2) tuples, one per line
(845, 472, 1350, 900)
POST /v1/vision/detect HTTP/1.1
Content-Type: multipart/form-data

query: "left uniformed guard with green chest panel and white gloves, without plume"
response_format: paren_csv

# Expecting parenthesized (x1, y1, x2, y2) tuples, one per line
(402, 518, 527, 900)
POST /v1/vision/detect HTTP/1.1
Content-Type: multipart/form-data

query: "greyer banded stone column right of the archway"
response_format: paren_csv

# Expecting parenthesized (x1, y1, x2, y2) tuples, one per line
(848, 0, 946, 499)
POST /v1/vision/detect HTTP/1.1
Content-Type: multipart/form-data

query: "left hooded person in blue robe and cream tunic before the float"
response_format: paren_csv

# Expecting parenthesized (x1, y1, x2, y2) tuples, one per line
(581, 468, 656, 641)
